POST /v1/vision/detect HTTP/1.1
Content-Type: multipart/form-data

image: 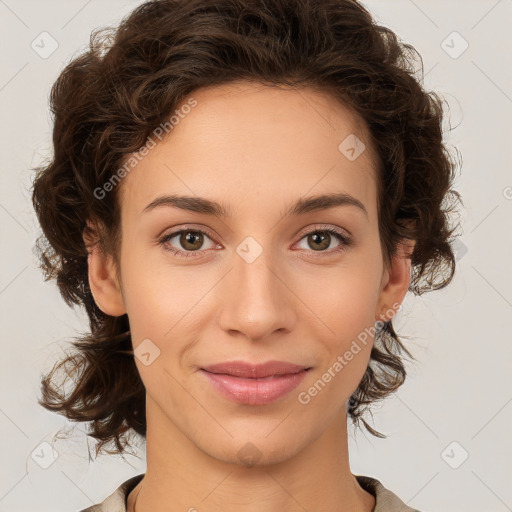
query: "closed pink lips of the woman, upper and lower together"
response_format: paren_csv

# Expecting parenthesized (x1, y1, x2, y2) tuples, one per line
(200, 361, 311, 405)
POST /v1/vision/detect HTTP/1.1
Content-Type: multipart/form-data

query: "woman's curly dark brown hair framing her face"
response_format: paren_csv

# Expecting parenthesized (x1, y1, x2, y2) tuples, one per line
(32, 0, 460, 454)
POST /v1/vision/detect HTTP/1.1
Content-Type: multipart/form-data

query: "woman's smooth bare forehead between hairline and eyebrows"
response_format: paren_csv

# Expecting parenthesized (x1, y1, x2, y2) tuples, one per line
(120, 82, 376, 218)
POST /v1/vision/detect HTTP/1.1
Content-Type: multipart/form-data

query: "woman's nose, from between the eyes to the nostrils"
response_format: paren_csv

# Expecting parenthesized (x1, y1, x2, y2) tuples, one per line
(219, 236, 294, 339)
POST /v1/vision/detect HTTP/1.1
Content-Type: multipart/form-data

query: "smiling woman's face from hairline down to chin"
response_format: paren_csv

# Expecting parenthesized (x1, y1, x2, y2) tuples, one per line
(86, 83, 408, 463)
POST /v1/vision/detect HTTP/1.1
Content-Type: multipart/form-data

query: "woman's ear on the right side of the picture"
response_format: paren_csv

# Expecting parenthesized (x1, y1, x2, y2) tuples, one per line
(375, 240, 415, 322)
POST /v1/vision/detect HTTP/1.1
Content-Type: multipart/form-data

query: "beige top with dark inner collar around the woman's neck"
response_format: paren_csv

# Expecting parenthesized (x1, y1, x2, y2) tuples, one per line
(80, 473, 419, 512)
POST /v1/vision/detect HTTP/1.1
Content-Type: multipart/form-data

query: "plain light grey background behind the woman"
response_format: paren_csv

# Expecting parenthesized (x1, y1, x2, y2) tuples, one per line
(0, 0, 512, 512)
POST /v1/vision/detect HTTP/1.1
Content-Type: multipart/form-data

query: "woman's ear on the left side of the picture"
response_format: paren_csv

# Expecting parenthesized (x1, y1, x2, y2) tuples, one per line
(82, 221, 126, 316)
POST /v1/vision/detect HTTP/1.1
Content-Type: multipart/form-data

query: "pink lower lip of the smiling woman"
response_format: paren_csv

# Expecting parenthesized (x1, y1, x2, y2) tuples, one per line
(201, 370, 308, 405)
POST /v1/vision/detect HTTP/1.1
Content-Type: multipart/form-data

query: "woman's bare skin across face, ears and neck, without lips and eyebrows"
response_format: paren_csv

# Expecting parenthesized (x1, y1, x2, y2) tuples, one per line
(83, 82, 412, 512)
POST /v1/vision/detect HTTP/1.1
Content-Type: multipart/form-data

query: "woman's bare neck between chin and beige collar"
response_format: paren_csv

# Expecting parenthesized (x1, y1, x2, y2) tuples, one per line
(128, 397, 375, 512)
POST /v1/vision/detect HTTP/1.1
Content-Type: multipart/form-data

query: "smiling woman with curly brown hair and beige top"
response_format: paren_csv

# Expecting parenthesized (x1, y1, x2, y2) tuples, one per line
(33, 0, 458, 512)
